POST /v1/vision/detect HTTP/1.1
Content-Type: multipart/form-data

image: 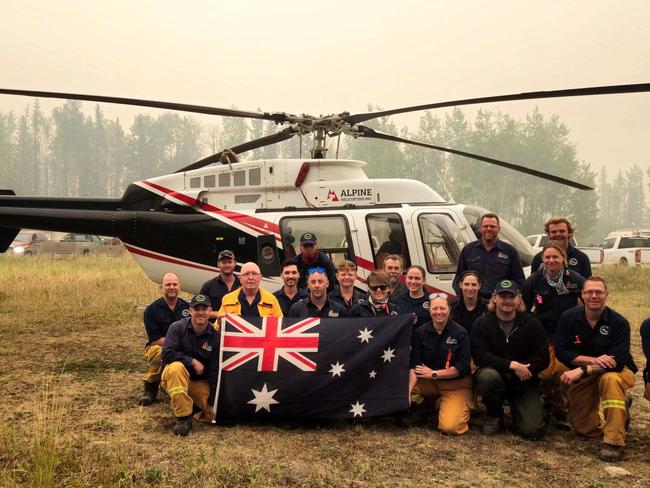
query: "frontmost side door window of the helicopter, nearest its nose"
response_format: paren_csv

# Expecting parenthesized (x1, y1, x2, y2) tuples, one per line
(418, 214, 465, 273)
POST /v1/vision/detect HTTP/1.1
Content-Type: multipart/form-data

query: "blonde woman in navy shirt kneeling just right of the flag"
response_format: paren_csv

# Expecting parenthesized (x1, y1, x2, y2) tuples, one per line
(402, 293, 472, 435)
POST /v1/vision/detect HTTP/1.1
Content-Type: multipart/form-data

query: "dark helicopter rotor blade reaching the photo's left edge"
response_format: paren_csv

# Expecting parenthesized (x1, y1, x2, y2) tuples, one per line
(0, 88, 287, 123)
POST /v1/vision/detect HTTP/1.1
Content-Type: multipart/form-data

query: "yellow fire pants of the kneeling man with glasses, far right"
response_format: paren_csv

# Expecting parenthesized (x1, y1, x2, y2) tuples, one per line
(569, 368, 634, 446)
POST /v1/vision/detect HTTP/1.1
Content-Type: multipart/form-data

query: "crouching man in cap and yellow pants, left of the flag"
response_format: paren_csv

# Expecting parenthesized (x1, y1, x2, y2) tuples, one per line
(162, 295, 219, 436)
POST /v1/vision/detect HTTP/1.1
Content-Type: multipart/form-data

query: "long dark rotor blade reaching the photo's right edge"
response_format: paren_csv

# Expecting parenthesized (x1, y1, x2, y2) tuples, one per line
(343, 83, 650, 124)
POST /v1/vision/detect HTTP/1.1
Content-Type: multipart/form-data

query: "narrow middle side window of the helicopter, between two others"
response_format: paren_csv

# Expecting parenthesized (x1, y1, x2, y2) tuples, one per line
(366, 213, 411, 269)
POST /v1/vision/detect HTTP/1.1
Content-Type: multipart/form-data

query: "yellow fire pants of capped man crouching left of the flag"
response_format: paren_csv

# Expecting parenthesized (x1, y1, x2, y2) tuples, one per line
(161, 361, 212, 422)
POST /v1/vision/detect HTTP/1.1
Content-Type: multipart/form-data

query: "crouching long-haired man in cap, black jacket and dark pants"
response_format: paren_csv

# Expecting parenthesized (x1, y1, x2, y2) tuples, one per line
(472, 280, 549, 439)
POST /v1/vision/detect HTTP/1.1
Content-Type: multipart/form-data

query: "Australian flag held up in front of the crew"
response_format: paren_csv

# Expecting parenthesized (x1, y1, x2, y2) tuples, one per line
(214, 315, 413, 422)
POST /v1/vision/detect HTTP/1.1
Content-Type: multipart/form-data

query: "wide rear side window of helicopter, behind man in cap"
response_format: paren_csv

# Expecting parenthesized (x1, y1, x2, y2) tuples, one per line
(280, 215, 354, 266)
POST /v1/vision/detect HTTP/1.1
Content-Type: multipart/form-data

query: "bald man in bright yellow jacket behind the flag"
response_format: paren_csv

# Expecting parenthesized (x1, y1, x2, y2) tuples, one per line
(217, 262, 283, 317)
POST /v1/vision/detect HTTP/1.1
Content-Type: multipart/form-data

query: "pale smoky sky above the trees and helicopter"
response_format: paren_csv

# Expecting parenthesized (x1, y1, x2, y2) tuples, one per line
(0, 0, 650, 174)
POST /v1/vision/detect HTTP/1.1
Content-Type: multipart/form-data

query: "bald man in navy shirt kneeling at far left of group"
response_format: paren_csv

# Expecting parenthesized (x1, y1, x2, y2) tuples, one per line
(138, 273, 189, 406)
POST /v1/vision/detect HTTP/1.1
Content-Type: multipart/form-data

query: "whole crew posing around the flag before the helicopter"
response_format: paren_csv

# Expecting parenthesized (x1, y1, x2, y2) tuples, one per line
(134, 214, 650, 460)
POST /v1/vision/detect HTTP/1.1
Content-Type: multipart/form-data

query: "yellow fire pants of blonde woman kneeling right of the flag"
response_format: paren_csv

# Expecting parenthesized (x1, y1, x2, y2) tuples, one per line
(411, 377, 472, 435)
